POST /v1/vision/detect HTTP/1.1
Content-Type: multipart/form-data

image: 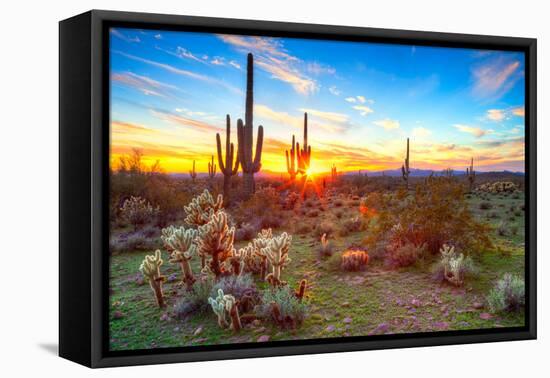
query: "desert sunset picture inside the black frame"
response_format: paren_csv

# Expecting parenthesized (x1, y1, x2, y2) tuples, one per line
(105, 28, 526, 351)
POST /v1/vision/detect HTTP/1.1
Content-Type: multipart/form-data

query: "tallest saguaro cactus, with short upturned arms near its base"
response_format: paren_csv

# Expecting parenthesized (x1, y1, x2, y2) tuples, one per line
(237, 54, 264, 197)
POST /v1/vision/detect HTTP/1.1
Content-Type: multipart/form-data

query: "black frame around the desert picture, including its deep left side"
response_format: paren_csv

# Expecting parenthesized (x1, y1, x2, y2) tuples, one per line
(59, 10, 537, 367)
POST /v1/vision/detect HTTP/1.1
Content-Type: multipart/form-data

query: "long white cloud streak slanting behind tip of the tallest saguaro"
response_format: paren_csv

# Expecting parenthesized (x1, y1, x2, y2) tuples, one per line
(219, 34, 319, 95)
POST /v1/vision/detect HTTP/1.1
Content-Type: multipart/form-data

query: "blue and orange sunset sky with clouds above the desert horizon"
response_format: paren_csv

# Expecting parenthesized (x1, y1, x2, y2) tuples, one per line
(110, 28, 525, 173)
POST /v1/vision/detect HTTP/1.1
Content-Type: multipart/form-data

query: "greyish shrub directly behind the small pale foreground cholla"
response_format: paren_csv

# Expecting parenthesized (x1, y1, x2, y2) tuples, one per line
(210, 274, 260, 313)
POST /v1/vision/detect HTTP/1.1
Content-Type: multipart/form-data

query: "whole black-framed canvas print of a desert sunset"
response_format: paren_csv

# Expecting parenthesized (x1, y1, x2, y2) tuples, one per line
(59, 11, 536, 367)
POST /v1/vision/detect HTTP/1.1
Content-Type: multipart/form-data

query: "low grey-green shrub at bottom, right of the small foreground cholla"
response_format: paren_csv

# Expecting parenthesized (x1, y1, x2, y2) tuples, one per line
(254, 286, 307, 328)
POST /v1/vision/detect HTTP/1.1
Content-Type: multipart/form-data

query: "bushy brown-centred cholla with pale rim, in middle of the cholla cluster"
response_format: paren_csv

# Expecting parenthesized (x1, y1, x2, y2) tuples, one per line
(197, 210, 235, 278)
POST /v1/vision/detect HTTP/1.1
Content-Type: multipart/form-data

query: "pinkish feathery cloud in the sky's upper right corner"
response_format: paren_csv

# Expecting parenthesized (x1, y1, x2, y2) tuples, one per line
(472, 57, 523, 100)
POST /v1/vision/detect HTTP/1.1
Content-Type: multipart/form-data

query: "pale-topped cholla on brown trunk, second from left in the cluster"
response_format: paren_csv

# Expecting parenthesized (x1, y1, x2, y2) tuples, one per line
(161, 227, 197, 289)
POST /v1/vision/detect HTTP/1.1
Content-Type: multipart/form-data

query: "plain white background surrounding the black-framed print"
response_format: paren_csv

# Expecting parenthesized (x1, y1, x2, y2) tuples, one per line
(0, 0, 550, 378)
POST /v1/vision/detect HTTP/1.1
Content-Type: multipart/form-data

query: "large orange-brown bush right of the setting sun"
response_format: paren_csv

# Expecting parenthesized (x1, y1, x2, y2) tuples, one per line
(360, 177, 492, 254)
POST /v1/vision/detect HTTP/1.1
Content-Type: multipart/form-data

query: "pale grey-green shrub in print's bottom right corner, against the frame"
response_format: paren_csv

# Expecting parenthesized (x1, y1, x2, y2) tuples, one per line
(487, 273, 525, 312)
